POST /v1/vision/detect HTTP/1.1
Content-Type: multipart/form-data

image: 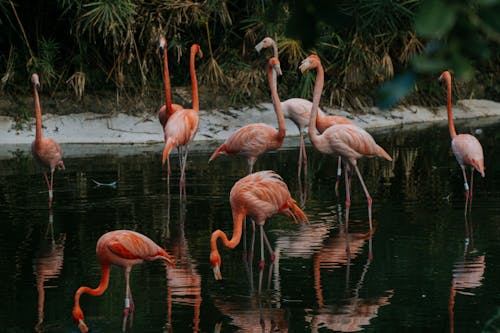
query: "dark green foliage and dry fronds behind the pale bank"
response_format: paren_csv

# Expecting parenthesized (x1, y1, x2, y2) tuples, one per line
(0, 0, 500, 116)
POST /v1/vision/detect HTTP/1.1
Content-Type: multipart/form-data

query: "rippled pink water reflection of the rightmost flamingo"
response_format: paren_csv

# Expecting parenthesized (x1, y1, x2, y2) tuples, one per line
(448, 215, 486, 333)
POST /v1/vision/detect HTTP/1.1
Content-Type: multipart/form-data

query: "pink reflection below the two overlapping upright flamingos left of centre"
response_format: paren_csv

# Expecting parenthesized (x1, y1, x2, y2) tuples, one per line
(167, 197, 202, 332)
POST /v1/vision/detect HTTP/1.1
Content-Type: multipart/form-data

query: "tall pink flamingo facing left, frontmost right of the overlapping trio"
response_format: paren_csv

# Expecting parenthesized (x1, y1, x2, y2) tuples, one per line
(300, 54, 392, 231)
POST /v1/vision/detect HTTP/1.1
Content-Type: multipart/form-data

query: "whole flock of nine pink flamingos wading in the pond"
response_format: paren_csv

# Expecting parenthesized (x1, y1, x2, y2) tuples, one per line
(25, 37, 485, 332)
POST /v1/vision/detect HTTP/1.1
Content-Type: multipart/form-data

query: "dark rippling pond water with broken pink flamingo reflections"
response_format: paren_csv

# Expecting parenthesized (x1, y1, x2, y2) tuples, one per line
(0, 120, 500, 332)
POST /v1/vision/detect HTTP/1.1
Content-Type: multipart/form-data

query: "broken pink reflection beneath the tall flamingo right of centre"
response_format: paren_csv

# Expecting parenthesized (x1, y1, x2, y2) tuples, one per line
(306, 220, 393, 332)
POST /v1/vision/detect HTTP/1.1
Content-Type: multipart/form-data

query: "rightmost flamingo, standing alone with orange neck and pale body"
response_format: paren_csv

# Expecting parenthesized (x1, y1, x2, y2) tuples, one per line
(439, 71, 485, 210)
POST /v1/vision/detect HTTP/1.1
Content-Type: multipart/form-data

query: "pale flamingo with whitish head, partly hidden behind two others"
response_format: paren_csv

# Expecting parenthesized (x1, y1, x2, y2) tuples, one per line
(255, 37, 352, 187)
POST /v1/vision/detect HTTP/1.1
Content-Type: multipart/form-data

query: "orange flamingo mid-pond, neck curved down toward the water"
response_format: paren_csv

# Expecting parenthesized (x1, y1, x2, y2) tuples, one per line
(210, 170, 309, 292)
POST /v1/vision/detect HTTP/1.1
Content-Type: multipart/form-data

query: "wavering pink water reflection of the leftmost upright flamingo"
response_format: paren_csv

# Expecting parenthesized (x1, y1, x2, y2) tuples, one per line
(33, 211, 66, 332)
